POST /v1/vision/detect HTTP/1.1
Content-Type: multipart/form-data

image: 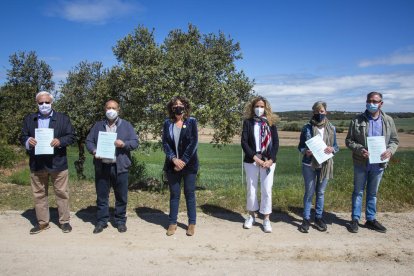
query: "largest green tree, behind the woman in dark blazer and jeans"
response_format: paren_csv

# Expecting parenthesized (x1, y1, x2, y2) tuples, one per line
(113, 24, 253, 145)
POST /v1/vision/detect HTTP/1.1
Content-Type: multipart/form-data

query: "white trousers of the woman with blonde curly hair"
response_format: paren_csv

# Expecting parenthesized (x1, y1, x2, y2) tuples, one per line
(244, 162, 276, 215)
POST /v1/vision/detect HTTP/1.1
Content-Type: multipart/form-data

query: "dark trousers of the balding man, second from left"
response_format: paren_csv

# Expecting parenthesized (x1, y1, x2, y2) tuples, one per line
(95, 163, 128, 226)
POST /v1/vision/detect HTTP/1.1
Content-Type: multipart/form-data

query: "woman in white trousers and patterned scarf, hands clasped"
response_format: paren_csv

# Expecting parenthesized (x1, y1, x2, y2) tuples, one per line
(241, 97, 279, 233)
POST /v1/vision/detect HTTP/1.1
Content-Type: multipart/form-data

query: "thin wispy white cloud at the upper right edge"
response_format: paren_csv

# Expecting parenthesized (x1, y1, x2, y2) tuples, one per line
(358, 46, 414, 67)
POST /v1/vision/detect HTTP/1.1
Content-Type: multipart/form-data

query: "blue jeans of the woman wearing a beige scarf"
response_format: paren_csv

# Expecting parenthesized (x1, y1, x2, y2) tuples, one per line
(302, 164, 328, 220)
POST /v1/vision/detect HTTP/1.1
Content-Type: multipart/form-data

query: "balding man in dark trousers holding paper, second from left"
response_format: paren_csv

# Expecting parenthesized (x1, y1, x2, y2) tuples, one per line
(86, 100, 138, 234)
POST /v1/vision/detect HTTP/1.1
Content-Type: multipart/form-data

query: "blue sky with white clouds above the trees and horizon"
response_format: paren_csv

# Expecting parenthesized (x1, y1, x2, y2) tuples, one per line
(0, 0, 414, 112)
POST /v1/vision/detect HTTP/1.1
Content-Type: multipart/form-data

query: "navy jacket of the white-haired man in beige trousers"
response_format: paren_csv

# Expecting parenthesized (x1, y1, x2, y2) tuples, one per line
(20, 110, 75, 172)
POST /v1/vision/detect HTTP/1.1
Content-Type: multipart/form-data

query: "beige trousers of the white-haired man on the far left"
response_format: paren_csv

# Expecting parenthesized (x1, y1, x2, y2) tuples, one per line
(30, 170, 70, 224)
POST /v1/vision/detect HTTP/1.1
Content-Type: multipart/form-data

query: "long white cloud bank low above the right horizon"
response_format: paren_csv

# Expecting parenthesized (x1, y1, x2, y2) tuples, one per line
(254, 73, 414, 112)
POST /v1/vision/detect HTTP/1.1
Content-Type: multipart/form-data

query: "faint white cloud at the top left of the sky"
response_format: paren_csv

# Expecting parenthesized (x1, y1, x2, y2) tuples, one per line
(47, 0, 142, 24)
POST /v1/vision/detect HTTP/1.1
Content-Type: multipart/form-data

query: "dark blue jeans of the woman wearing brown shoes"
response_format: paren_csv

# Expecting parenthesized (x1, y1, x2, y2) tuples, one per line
(167, 172, 197, 224)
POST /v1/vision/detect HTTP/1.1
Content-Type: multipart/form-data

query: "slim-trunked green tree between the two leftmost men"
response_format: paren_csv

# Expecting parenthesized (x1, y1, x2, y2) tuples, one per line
(56, 61, 111, 179)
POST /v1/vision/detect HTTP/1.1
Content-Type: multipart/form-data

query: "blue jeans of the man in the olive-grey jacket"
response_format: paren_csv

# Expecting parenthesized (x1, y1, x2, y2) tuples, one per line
(352, 166, 384, 220)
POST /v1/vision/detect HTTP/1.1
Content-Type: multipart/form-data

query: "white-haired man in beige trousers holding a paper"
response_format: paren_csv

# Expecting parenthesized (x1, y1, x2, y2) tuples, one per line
(21, 91, 75, 234)
